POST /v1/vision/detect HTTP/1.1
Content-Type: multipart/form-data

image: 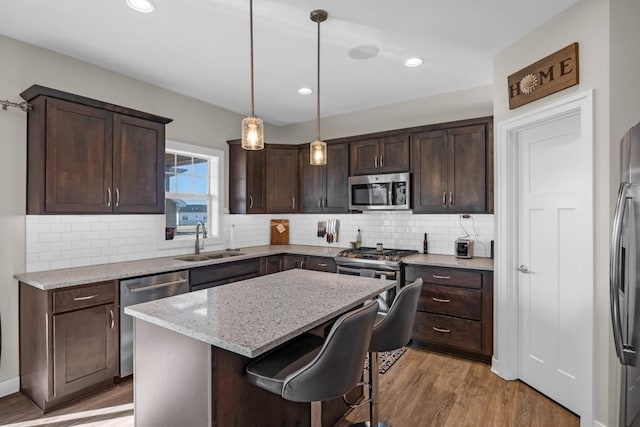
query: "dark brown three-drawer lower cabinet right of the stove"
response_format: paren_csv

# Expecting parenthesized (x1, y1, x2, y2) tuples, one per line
(405, 265, 493, 362)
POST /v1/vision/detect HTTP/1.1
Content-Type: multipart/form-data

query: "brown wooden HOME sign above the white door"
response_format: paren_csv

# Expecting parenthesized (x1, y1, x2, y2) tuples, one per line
(507, 43, 580, 110)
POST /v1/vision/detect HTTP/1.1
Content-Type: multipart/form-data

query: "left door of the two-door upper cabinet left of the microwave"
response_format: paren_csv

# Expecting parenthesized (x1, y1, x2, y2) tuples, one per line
(298, 144, 322, 213)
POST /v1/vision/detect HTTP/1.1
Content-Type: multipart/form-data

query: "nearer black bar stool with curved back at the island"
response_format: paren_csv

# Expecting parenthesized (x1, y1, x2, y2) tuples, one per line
(246, 301, 378, 427)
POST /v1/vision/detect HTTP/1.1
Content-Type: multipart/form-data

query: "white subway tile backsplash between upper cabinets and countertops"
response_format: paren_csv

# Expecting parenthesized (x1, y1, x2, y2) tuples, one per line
(25, 212, 494, 271)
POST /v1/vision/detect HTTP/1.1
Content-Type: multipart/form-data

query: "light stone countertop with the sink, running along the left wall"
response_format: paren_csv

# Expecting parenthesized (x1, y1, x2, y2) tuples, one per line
(13, 245, 343, 290)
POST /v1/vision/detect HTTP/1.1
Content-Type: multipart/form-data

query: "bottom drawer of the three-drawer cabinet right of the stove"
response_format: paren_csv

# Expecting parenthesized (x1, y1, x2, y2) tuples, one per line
(413, 312, 482, 352)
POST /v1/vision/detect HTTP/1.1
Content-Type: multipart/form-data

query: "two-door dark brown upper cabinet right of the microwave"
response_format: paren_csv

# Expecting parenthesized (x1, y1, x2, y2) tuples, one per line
(411, 120, 493, 213)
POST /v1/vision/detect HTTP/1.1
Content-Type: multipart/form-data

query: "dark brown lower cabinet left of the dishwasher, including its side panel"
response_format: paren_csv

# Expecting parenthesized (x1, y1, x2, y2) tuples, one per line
(19, 281, 119, 411)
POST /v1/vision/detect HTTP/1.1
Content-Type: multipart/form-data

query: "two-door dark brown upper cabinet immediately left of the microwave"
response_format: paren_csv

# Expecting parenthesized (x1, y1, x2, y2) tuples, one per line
(298, 143, 349, 213)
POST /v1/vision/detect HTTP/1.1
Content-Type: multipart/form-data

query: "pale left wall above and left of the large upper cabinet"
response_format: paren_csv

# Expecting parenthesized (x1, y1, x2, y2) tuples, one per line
(0, 36, 271, 394)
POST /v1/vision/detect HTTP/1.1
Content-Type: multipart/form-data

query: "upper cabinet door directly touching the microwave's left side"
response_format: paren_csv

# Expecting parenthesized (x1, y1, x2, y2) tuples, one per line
(324, 143, 349, 213)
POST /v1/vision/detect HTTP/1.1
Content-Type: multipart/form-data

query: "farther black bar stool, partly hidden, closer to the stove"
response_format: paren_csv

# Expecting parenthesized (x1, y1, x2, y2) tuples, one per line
(354, 278, 422, 427)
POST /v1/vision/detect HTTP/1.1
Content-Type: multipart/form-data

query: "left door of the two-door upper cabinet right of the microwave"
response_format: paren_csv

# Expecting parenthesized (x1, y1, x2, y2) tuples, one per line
(411, 130, 448, 213)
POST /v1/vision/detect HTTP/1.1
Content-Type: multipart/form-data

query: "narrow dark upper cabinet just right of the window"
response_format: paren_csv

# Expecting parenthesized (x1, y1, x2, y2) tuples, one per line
(228, 140, 267, 214)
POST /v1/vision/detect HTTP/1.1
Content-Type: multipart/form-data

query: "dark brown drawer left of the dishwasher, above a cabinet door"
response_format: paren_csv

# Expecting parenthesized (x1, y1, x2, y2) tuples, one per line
(53, 281, 116, 313)
